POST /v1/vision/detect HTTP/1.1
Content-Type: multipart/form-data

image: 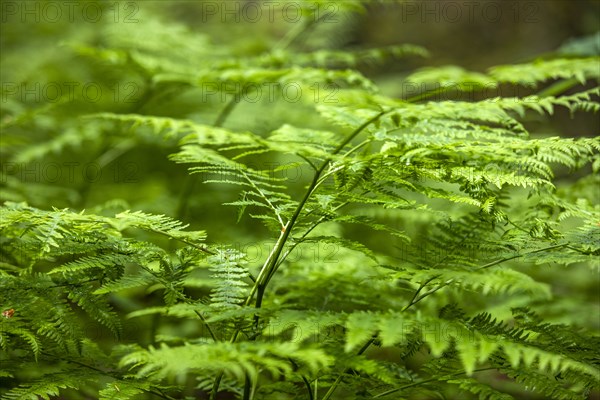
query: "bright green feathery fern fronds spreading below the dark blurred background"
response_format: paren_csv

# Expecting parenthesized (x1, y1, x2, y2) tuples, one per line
(0, 1, 600, 400)
